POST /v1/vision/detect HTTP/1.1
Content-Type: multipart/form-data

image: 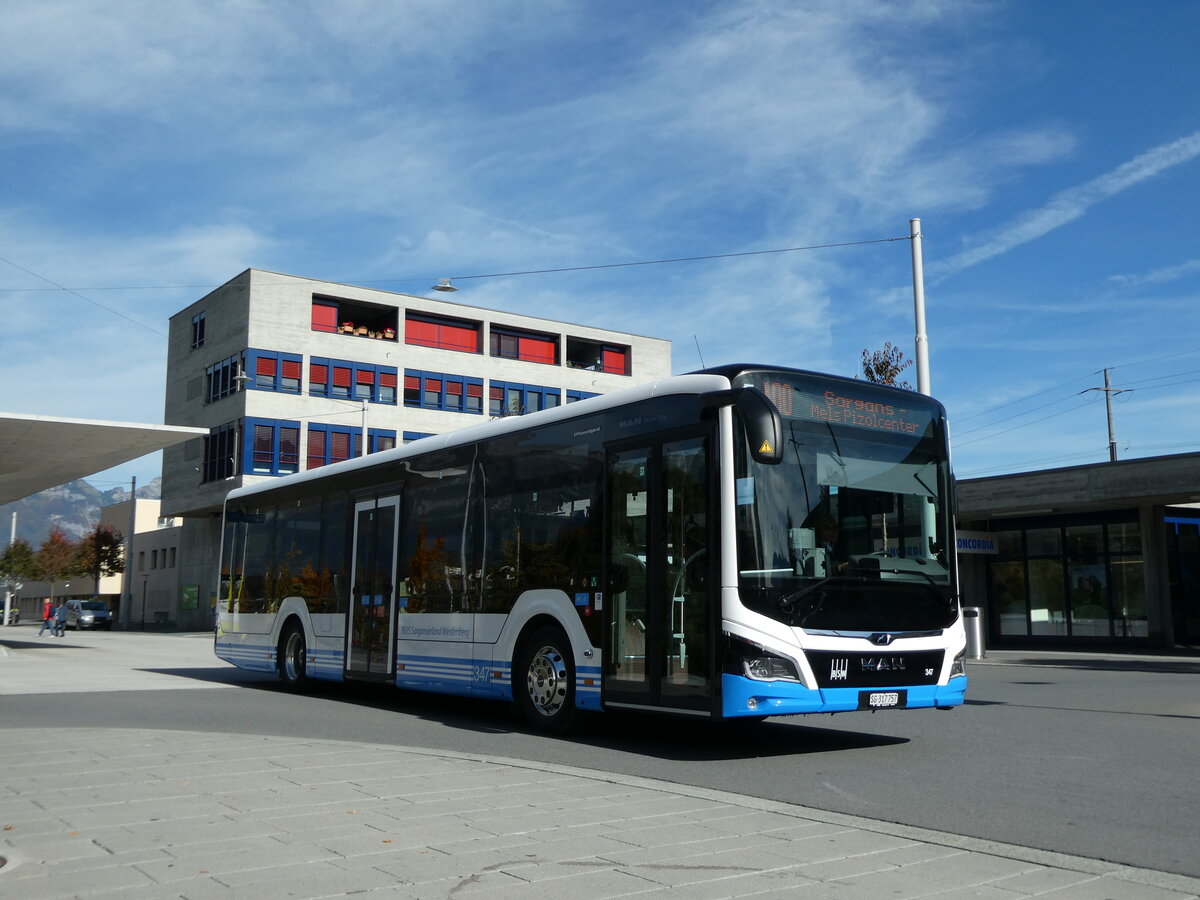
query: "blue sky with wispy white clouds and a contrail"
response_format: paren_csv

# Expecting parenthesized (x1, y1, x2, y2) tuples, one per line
(0, 0, 1200, 494)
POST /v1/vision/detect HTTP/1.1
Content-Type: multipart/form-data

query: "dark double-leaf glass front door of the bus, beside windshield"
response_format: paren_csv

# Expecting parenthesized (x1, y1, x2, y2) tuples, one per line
(604, 434, 718, 714)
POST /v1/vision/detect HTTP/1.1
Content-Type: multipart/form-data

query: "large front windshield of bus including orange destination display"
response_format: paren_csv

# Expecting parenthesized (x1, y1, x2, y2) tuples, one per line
(736, 372, 958, 634)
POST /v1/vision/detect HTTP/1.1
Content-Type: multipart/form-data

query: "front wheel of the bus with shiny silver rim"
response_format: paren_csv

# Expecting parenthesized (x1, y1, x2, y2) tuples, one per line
(512, 626, 575, 734)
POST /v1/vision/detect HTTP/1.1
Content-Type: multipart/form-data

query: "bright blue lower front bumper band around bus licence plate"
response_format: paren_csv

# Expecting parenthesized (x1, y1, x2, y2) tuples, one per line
(721, 674, 967, 716)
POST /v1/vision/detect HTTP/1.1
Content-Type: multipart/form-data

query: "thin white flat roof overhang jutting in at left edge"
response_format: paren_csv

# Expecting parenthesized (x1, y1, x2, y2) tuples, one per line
(0, 413, 209, 504)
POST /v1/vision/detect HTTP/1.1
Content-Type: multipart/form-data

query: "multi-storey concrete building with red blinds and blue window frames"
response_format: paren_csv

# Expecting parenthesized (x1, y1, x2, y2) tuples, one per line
(157, 269, 671, 628)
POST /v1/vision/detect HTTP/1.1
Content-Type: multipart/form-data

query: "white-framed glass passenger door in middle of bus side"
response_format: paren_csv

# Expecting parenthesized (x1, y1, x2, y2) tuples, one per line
(346, 497, 400, 680)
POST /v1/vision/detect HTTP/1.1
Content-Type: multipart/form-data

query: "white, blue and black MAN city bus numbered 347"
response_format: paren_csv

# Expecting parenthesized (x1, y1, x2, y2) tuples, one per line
(216, 365, 967, 732)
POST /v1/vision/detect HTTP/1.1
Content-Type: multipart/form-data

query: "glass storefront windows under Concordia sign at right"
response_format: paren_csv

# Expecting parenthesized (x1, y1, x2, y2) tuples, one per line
(988, 512, 1150, 642)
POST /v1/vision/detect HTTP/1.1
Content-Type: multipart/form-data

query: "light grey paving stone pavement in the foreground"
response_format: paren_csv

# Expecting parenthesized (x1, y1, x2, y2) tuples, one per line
(0, 728, 1200, 900)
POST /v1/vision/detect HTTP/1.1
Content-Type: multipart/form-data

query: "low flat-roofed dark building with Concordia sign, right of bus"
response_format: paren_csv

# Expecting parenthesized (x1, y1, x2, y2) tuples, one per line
(958, 454, 1200, 650)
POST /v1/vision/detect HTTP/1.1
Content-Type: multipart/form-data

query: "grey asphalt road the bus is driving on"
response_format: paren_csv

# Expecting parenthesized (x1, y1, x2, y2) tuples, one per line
(7, 629, 1200, 877)
